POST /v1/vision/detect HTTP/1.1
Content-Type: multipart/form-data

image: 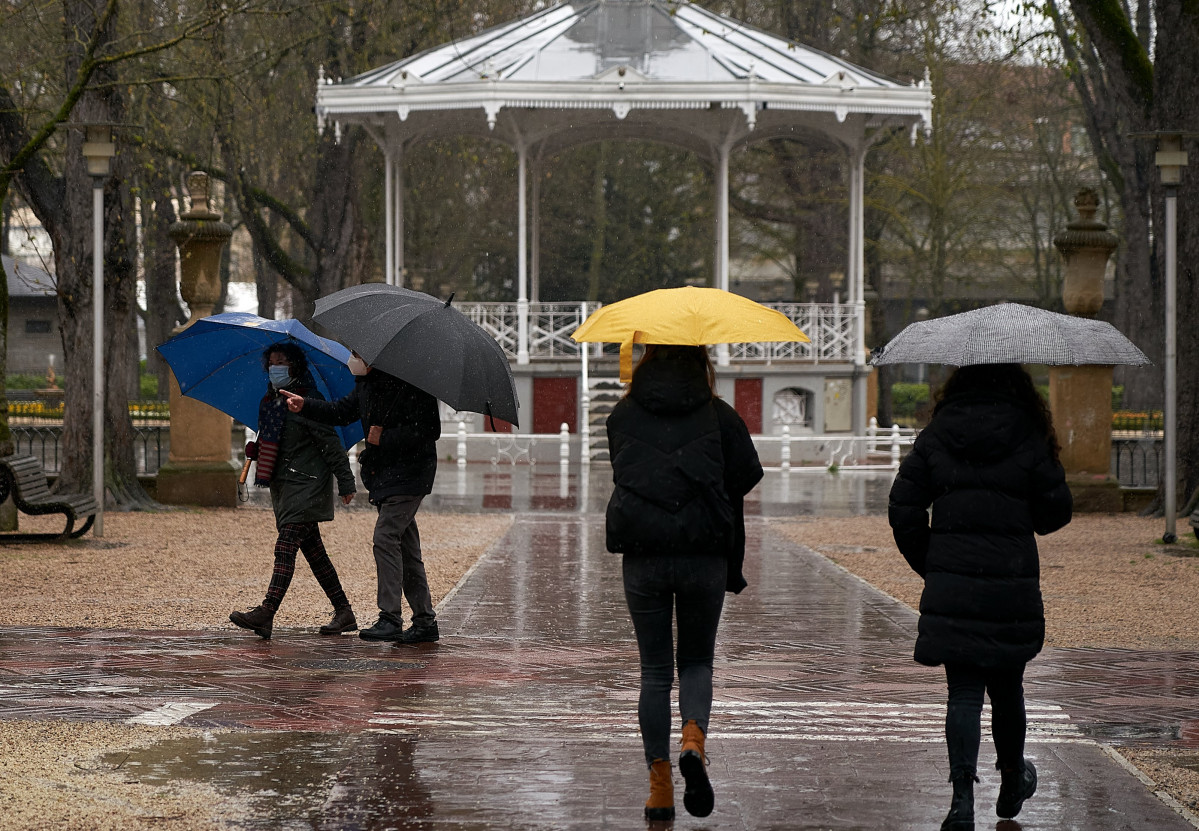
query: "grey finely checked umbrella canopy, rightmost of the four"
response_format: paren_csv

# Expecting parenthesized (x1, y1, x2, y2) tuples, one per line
(870, 303, 1150, 367)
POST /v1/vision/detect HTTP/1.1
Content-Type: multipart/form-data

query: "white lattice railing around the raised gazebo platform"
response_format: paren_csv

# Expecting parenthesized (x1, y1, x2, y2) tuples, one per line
(457, 301, 857, 363)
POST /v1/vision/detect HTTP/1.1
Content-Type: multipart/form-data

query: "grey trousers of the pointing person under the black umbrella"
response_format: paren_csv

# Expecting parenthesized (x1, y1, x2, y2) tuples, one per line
(374, 495, 436, 625)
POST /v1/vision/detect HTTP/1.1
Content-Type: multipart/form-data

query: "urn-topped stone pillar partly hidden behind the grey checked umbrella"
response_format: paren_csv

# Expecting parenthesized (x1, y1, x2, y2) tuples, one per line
(1049, 188, 1123, 512)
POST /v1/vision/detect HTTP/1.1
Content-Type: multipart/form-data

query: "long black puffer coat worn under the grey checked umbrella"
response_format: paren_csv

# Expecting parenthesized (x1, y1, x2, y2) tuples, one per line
(888, 392, 1073, 669)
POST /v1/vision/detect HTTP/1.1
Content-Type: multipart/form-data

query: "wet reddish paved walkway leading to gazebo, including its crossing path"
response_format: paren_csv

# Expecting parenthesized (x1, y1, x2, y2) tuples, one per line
(0, 475, 1199, 831)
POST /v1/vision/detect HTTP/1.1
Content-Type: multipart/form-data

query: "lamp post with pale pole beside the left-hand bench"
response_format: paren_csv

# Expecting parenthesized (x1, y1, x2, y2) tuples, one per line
(83, 124, 116, 537)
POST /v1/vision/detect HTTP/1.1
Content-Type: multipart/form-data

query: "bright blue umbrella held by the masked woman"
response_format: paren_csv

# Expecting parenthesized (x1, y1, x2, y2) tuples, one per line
(158, 312, 362, 447)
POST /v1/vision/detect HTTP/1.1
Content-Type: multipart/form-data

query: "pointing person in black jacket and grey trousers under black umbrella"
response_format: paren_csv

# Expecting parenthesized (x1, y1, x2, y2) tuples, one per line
(282, 353, 441, 644)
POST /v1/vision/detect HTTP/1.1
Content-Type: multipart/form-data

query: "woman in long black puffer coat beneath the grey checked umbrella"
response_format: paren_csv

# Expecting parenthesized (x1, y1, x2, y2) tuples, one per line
(890, 363, 1073, 831)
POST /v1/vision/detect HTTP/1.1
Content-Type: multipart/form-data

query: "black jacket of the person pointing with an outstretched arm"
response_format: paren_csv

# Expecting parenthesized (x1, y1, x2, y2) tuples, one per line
(302, 369, 441, 505)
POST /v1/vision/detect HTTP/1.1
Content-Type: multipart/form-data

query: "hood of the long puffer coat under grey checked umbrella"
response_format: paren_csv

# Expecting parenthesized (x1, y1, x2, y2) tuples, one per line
(929, 392, 1034, 462)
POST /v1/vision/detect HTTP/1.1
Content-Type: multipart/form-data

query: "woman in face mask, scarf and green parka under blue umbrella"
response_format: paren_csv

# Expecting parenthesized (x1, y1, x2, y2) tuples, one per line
(229, 342, 359, 638)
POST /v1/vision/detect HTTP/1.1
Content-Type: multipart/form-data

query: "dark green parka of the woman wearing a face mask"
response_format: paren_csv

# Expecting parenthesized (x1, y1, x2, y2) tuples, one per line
(271, 413, 357, 528)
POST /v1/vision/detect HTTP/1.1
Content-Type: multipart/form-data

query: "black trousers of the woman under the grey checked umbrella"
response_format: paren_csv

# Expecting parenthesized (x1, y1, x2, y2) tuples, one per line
(945, 664, 1028, 781)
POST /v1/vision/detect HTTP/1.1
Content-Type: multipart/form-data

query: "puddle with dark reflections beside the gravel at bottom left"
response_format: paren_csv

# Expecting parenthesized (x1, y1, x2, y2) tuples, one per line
(101, 733, 433, 831)
